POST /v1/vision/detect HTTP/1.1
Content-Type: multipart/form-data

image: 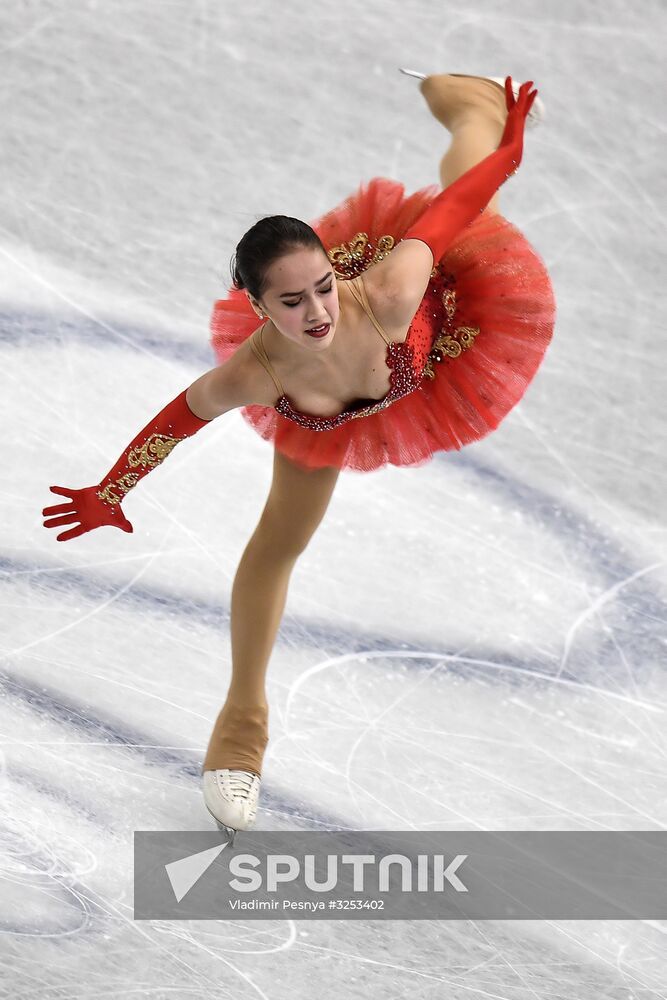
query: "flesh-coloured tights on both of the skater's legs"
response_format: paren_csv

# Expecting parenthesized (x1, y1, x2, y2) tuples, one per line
(202, 74, 507, 774)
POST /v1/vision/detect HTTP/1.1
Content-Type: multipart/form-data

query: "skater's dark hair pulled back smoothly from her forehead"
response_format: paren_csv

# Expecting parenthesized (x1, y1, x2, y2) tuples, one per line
(230, 215, 327, 301)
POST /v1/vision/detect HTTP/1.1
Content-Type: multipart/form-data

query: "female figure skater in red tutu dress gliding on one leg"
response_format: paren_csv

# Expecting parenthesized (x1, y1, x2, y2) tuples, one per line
(42, 70, 555, 839)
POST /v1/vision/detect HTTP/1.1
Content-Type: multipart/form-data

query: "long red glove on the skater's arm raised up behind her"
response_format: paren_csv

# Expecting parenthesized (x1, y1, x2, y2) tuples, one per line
(403, 76, 538, 262)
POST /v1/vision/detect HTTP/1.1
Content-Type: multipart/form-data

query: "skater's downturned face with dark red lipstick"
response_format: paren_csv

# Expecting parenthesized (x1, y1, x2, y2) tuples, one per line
(253, 247, 340, 352)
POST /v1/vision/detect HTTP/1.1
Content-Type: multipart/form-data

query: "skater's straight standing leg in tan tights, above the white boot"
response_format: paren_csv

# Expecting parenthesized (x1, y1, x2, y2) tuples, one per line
(202, 449, 340, 774)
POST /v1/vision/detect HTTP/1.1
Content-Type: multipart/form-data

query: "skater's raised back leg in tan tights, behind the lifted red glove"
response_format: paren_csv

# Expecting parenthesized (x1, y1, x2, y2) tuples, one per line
(420, 74, 507, 212)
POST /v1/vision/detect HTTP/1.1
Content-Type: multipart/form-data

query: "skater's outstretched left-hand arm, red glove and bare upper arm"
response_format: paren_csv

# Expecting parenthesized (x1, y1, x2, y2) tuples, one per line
(42, 355, 254, 542)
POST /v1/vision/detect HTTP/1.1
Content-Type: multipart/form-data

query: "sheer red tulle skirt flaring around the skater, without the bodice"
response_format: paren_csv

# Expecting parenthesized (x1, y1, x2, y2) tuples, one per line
(211, 177, 556, 472)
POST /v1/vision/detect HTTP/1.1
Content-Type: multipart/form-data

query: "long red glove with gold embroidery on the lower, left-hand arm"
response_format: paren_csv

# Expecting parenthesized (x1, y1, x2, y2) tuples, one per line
(42, 389, 210, 542)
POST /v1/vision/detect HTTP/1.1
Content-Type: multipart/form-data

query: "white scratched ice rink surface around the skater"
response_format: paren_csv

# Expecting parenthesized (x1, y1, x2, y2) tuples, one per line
(0, 0, 667, 1000)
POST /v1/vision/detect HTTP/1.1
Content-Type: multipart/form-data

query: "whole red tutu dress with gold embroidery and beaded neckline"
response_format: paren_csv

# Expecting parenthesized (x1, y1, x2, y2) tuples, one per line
(211, 177, 556, 472)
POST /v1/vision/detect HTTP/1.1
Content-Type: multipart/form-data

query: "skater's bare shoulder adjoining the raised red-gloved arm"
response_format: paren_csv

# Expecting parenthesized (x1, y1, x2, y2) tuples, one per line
(364, 239, 433, 328)
